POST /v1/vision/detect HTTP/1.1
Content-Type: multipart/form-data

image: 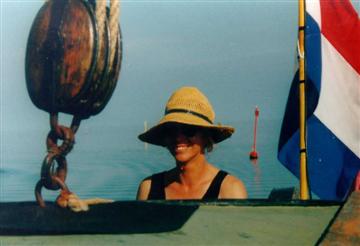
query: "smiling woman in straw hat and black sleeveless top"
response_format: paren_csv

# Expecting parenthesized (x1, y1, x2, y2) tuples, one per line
(137, 87, 247, 200)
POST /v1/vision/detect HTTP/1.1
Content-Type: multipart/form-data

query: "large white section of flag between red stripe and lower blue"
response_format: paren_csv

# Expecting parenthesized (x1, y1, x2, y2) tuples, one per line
(314, 35, 360, 158)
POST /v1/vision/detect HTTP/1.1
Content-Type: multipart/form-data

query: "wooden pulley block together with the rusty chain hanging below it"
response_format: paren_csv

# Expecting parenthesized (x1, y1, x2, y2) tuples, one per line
(25, 0, 122, 207)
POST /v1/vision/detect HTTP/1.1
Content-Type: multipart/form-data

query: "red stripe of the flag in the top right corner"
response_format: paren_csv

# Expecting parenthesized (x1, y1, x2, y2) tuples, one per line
(320, 0, 360, 74)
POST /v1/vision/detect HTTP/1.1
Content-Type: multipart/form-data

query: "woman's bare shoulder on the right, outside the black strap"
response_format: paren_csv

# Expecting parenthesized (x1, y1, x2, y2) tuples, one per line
(219, 174, 247, 199)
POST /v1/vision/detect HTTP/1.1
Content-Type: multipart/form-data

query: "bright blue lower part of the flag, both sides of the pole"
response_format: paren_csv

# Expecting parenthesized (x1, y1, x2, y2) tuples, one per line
(278, 116, 359, 200)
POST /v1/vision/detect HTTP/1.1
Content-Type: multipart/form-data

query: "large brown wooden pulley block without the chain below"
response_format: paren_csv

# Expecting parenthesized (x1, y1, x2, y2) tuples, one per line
(25, 0, 122, 118)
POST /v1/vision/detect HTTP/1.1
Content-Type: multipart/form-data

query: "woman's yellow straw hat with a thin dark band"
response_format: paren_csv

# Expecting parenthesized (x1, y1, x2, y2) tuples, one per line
(139, 87, 235, 146)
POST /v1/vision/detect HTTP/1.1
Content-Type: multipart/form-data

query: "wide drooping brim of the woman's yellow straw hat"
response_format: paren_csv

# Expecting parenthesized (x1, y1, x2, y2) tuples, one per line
(138, 113, 235, 146)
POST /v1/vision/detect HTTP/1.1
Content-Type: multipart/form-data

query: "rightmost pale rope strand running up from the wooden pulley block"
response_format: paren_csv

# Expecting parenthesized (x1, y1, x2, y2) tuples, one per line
(109, 0, 120, 68)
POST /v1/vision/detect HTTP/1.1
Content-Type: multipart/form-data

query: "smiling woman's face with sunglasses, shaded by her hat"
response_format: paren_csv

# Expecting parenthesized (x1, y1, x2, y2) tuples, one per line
(165, 125, 205, 163)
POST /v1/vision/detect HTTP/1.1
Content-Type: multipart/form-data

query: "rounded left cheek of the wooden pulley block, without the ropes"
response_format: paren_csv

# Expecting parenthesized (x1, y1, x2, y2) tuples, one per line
(25, 0, 97, 113)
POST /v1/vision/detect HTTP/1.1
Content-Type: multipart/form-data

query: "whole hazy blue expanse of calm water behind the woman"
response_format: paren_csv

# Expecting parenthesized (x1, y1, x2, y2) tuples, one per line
(0, 1, 298, 201)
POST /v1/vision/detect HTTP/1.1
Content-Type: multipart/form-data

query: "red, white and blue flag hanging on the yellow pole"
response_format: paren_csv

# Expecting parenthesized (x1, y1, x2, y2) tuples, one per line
(278, 0, 360, 200)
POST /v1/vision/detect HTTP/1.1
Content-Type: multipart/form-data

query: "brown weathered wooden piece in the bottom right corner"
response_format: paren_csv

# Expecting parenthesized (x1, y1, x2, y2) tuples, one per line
(321, 191, 360, 245)
